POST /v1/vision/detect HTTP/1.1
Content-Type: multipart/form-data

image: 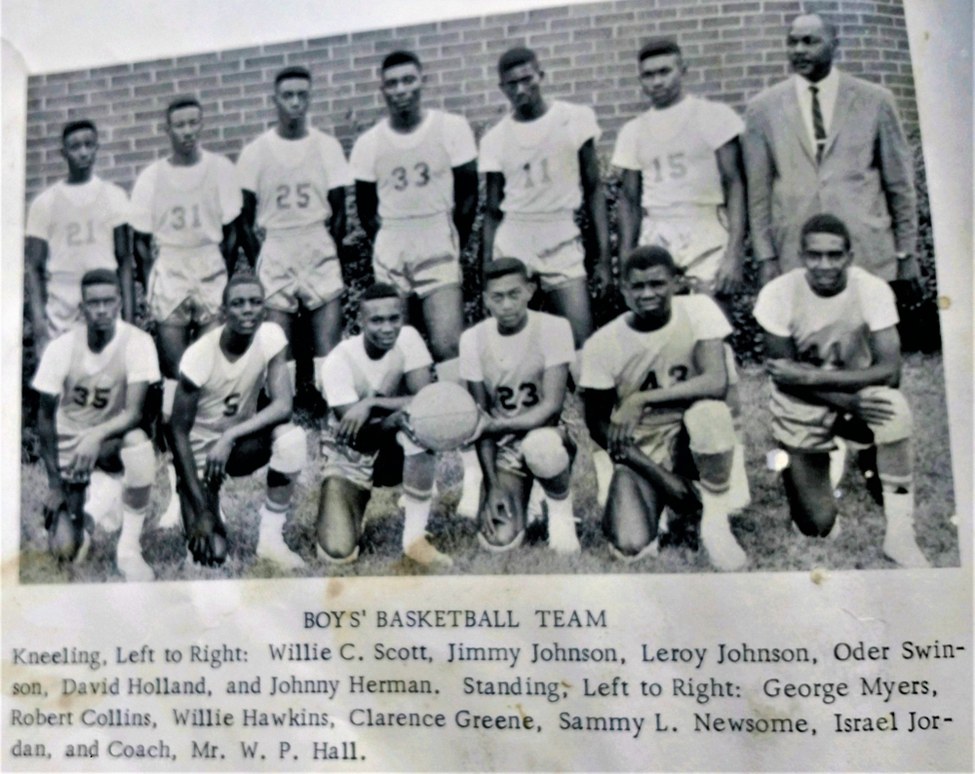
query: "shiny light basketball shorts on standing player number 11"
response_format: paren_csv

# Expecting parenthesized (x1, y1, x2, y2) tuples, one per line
(494, 213, 586, 291)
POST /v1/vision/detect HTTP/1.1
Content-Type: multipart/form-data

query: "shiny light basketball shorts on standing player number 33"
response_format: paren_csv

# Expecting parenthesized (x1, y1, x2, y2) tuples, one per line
(372, 213, 461, 298)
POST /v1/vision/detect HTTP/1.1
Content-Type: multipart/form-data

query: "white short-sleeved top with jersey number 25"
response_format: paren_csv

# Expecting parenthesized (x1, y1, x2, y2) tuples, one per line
(237, 128, 352, 229)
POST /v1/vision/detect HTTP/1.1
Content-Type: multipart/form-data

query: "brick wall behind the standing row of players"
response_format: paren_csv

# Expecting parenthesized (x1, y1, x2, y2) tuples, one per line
(27, 0, 917, 198)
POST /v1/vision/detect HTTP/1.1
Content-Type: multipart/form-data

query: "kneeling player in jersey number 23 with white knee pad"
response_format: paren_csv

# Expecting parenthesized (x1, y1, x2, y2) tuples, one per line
(460, 258, 580, 554)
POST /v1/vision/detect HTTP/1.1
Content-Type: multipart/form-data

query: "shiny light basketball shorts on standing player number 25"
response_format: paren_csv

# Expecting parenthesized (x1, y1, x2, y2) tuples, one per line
(257, 224, 344, 314)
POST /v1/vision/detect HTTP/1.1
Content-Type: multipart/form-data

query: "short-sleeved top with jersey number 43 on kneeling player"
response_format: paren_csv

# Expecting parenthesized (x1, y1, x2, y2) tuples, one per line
(579, 294, 731, 428)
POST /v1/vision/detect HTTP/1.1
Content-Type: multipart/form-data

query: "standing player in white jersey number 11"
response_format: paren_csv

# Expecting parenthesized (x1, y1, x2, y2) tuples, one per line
(479, 48, 611, 348)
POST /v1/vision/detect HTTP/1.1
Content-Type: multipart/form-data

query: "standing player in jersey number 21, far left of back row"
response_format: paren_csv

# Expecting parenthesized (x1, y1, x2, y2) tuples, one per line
(24, 121, 133, 352)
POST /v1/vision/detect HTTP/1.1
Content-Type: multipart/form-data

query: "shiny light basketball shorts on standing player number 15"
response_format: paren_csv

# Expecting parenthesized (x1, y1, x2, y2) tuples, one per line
(640, 205, 728, 295)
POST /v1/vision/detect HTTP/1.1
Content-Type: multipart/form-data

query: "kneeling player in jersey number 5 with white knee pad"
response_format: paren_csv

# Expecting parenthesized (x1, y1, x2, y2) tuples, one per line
(171, 274, 307, 569)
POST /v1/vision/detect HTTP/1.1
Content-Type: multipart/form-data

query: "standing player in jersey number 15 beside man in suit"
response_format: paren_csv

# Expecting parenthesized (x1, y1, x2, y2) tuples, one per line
(613, 38, 745, 301)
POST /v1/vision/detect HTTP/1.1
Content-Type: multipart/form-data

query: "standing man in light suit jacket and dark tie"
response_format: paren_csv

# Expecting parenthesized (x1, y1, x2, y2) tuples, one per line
(744, 14, 918, 284)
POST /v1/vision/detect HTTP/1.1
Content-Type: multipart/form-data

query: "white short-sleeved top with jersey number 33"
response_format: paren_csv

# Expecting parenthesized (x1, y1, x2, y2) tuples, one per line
(351, 110, 477, 219)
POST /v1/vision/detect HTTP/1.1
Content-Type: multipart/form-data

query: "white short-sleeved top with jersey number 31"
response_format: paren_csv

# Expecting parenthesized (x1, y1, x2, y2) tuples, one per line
(132, 151, 241, 247)
